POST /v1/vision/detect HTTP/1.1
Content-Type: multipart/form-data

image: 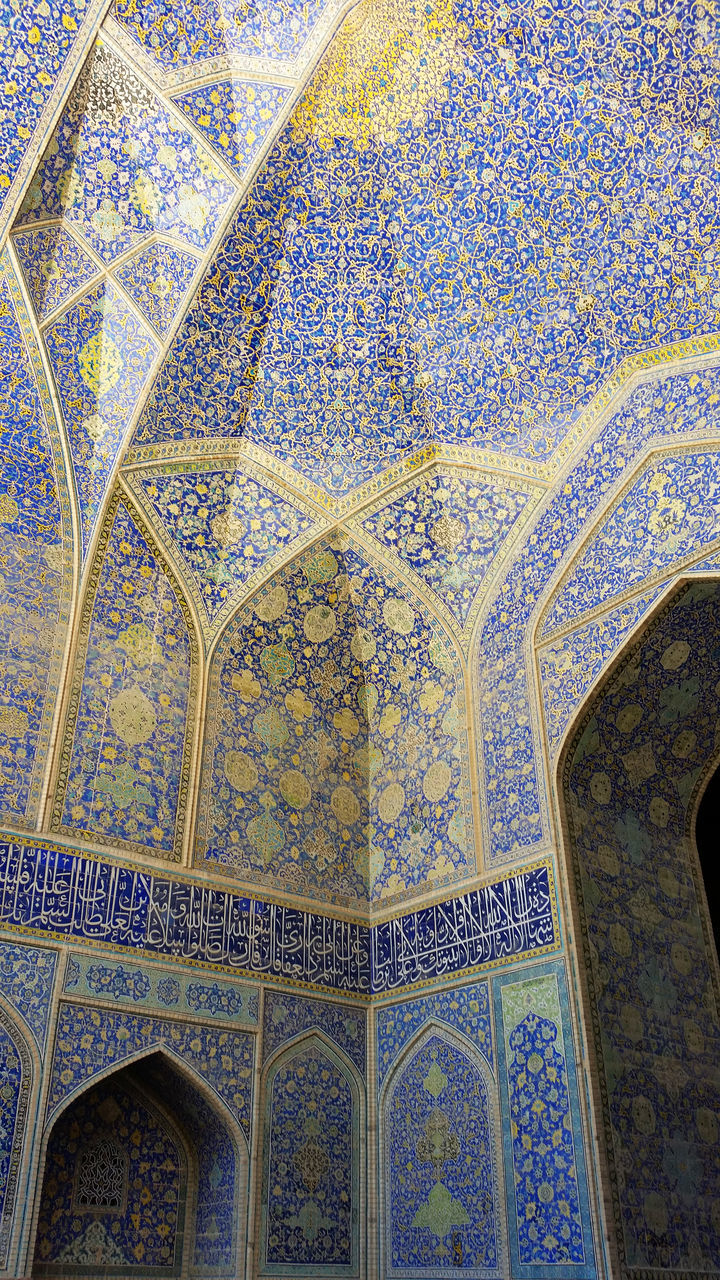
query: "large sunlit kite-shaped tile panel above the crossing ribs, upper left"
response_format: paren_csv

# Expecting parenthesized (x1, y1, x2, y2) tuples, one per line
(17, 42, 233, 262)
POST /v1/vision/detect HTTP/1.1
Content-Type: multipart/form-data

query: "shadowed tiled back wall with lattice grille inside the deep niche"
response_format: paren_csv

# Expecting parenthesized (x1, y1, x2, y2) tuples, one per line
(33, 1079, 184, 1277)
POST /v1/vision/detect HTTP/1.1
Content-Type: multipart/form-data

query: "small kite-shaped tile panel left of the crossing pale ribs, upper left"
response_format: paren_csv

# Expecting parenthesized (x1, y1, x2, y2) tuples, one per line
(13, 227, 97, 320)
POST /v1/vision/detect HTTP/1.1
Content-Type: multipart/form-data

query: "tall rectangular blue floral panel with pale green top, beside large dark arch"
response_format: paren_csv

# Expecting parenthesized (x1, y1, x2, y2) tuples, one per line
(496, 968, 596, 1280)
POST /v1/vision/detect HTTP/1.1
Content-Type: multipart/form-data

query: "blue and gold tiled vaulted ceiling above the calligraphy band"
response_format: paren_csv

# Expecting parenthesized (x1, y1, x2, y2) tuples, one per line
(0, 0, 720, 916)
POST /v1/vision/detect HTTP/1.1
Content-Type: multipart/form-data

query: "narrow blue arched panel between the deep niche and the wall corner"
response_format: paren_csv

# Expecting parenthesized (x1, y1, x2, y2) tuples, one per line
(259, 1032, 365, 1277)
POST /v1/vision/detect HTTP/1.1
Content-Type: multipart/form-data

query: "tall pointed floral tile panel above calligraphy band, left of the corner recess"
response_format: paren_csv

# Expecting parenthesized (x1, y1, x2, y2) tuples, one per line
(53, 502, 197, 859)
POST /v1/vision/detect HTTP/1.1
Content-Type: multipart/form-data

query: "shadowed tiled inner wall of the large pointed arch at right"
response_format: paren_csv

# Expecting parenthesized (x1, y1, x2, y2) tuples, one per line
(559, 580, 720, 1275)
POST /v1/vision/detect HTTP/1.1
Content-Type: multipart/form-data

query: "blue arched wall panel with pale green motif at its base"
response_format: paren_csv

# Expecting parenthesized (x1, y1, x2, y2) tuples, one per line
(379, 1021, 505, 1280)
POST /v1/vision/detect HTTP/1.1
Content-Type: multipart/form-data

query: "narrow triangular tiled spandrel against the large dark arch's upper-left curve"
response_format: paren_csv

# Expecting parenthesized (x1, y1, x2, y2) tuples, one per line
(539, 584, 665, 750)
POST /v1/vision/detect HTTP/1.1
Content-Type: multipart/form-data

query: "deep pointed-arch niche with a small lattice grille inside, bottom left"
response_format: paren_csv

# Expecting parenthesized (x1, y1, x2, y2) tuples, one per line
(31, 1048, 247, 1280)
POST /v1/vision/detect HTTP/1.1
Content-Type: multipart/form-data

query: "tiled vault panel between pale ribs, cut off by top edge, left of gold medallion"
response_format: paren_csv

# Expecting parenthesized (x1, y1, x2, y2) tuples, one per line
(113, 0, 327, 68)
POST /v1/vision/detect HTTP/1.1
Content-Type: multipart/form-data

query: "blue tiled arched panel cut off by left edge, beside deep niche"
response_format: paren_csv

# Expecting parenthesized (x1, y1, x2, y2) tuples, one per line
(0, 1007, 32, 1267)
